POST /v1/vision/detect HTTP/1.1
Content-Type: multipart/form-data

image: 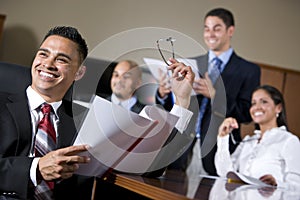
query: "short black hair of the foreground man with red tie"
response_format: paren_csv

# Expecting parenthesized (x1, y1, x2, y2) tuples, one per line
(43, 26, 88, 62)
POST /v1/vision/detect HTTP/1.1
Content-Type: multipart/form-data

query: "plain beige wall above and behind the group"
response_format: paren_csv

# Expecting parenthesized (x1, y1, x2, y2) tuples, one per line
(0, 0, 300, 71)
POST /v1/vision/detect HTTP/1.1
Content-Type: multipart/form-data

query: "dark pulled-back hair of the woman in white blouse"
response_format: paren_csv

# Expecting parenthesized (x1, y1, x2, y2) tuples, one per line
(252, 85, 288, 130)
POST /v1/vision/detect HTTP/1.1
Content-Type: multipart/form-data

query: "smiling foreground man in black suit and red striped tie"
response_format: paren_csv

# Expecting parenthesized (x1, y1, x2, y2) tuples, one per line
(0, 26, 93, 199)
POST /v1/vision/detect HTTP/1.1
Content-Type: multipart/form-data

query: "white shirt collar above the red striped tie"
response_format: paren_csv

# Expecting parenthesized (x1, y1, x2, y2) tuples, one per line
(26, 86, 62, 117)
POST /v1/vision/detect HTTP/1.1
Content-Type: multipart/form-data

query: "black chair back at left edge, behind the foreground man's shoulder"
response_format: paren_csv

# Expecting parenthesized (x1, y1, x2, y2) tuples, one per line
(0, 62, 31, 93)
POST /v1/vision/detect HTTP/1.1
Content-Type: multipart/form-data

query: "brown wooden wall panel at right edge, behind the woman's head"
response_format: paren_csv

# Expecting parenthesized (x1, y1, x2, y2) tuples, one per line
(283, 72, 300, 137)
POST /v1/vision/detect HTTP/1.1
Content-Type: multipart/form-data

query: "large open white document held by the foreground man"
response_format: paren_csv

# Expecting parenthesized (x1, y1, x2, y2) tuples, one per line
(74, 96, 178, 176)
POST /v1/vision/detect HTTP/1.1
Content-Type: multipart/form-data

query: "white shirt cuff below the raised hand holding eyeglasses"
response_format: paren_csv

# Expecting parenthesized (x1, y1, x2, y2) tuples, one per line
(170, 104, 193, 133)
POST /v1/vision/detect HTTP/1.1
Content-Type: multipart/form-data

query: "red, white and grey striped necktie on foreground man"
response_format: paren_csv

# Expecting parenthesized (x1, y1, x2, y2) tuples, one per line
(35, 104, 56, 199)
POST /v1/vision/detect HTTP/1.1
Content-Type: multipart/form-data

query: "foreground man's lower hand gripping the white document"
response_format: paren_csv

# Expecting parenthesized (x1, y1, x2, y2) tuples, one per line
(37, 145, 90, 181)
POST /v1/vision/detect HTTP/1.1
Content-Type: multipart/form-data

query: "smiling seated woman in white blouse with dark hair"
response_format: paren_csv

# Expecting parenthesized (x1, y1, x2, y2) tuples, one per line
(215, 85, 300, 191)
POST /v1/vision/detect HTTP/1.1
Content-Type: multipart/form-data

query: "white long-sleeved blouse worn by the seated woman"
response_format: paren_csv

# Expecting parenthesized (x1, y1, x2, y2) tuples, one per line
(215, 126, 300, 190)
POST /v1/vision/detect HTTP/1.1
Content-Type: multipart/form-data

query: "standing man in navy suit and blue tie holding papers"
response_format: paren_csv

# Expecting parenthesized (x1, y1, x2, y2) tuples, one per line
(156, 8, 261, 175)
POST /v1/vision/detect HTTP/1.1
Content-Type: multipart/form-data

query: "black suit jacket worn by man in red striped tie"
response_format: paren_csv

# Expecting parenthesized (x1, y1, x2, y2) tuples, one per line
(0, 92, 92, 199)
